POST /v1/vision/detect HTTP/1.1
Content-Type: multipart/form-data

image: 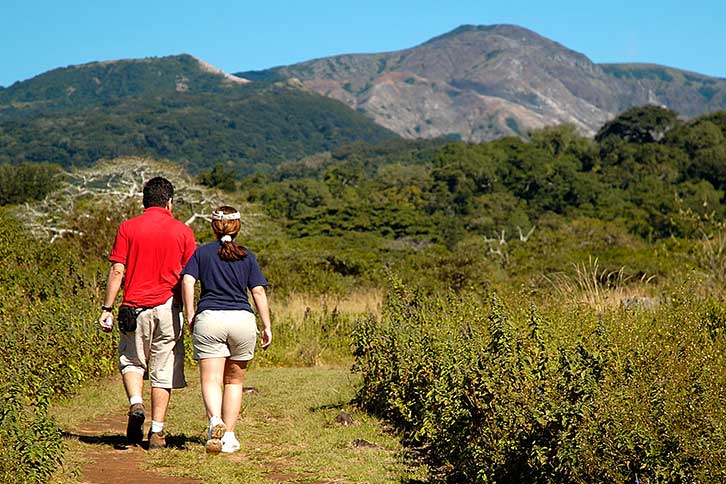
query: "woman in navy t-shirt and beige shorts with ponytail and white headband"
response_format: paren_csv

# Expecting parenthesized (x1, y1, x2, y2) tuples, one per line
(182, 206, 272, 453)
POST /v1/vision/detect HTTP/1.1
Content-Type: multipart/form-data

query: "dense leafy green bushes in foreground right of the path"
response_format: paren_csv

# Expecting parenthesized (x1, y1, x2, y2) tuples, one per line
(354, 285, 726, 483)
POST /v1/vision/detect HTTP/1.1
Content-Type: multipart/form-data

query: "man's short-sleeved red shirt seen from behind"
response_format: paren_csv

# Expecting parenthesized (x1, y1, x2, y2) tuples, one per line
(109, 207, 196, 307)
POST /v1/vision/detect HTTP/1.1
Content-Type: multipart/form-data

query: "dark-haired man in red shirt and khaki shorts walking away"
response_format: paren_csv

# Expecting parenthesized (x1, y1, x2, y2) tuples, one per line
(99, 177, 196, 449)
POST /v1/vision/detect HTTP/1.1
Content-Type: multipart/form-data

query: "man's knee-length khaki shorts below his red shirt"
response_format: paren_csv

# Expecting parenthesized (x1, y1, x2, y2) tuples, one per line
(119, 298, 187, 388)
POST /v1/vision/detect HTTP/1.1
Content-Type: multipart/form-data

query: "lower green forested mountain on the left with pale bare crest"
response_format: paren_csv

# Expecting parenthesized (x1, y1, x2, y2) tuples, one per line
(0, 55, 398, 174)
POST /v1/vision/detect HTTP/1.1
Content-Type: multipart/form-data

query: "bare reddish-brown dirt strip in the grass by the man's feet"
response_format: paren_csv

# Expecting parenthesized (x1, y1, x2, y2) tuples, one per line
(66, 416, 202, 484)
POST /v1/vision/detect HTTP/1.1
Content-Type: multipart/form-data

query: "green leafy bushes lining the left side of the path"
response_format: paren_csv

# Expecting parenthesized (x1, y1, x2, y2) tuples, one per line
(0, 211, 115, 483)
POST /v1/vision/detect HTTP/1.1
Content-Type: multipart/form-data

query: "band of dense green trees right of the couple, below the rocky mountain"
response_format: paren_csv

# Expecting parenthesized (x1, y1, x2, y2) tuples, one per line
(243, 106, 726, 247)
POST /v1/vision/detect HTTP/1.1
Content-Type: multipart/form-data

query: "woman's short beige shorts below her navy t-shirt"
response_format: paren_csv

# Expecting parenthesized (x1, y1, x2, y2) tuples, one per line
(192, 310, 257, 361)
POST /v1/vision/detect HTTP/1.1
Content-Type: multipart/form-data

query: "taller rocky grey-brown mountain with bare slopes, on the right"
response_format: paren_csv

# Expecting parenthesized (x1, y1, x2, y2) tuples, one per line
(238, 25, 726, 141)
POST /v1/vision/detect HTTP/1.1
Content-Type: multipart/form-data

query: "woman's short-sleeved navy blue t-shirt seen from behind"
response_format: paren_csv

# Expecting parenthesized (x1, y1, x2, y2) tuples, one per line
(182, 241, 267, 313)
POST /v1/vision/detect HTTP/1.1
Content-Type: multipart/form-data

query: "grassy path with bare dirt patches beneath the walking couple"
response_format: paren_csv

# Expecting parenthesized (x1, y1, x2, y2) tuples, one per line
(53, 367, 411, 484)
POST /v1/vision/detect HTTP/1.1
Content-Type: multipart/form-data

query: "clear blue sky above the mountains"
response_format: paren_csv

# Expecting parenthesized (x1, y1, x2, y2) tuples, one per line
(0, 0, 726, 87)
